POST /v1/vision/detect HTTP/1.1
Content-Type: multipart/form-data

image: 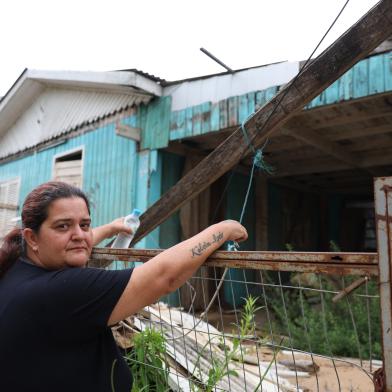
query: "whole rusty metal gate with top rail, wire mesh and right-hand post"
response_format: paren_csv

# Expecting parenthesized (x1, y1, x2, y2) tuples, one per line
(92, 178, 392, 391)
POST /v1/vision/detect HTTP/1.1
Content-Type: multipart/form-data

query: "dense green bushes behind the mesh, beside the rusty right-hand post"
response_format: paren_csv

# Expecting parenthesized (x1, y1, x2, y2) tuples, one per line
(266, 277, 381, 359)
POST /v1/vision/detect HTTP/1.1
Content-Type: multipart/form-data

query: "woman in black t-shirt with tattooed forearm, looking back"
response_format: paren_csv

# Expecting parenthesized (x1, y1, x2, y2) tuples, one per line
(0, 182, 247, 392)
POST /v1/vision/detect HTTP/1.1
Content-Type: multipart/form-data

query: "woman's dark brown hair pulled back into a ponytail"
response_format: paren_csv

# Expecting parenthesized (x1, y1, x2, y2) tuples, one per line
(0, 181, 90, 278)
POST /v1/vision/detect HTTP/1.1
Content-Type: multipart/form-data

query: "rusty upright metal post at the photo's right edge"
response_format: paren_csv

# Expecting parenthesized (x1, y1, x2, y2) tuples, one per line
(374, 177, 392, 392)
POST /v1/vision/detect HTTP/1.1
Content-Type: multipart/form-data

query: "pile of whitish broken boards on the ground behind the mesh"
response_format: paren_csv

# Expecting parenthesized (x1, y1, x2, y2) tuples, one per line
(113, 303, 319, 392)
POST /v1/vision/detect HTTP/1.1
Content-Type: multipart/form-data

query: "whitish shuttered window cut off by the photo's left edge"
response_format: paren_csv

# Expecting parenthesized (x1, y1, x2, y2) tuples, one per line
(0, 178, 20, 243)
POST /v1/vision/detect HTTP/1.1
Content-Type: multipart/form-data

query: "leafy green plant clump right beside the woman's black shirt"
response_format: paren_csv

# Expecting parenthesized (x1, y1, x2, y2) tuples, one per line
(125, 328, 170, 392)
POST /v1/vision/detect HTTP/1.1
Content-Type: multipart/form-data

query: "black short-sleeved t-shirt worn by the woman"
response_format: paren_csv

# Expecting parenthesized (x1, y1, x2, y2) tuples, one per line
(0, 259, 132, 392)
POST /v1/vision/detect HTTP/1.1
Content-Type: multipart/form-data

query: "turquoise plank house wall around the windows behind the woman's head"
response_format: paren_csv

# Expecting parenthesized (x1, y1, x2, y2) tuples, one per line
(0, 116, 162, 248)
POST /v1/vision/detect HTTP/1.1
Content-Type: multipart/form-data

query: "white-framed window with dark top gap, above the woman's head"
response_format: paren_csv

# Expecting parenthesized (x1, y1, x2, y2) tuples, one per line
(53, 149, 83, 188)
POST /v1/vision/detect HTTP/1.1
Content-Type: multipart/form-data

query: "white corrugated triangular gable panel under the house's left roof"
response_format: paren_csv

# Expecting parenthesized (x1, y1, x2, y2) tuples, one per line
(0, 88, 152, 158)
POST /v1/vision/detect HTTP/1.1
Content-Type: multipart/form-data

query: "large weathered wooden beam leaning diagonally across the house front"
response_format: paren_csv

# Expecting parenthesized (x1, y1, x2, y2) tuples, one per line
(133, 0, 392, 243)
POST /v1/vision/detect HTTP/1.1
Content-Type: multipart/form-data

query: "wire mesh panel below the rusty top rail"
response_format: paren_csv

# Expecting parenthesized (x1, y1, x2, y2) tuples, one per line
(91, 251, 382, 391)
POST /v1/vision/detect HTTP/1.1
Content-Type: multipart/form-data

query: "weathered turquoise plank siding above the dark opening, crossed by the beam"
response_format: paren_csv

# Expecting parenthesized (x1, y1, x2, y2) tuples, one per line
(166, 52, 392, 141)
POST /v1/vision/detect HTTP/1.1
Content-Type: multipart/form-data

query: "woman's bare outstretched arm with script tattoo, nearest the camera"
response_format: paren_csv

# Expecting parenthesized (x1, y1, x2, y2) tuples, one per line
(108, 220, 248, 325)
